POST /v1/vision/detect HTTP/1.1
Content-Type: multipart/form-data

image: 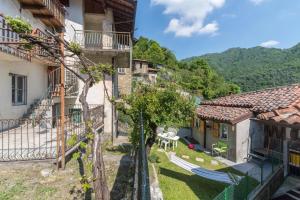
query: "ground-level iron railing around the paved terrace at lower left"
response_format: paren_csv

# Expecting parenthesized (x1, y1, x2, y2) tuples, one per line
(0, 105, 104, 162)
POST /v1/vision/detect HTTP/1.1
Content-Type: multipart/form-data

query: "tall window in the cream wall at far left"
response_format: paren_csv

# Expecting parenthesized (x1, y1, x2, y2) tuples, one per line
(11, 74, 27, 105)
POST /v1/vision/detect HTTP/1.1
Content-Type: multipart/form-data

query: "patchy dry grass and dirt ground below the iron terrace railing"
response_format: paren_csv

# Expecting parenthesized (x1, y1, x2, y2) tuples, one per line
(0, 144, 133, 200)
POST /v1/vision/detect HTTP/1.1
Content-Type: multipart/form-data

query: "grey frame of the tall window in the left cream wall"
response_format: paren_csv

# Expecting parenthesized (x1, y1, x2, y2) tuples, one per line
(10, 74, 27, 106)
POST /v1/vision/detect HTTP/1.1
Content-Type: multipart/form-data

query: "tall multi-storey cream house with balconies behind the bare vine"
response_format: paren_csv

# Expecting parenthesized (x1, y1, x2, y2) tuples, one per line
(0, 0, 136, 136)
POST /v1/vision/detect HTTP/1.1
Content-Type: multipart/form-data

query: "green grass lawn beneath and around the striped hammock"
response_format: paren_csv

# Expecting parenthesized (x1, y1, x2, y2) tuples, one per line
(149, 141, 257, 200)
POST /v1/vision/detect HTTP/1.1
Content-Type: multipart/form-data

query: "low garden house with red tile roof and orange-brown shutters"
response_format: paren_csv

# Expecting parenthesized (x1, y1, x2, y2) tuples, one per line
(192, 84, 300, 176)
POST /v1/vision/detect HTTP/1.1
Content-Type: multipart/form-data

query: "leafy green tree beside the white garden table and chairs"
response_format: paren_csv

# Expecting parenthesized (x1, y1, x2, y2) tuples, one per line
(118, 84, 195, 152)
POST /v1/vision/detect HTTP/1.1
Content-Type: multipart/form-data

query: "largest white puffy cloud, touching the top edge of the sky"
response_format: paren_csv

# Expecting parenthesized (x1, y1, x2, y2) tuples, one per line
(151, 0, 225, 37)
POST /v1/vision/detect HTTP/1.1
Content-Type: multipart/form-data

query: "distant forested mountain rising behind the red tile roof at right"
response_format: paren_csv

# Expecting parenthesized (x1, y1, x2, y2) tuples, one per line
(183, 43, 300, 91)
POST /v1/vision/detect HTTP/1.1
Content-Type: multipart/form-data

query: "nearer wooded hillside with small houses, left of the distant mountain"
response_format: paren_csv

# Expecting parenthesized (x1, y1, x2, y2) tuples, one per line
(133, 37, 240, 99)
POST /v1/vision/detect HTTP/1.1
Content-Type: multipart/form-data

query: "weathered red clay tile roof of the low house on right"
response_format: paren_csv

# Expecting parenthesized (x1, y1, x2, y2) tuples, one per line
(197, 84, 300, 124)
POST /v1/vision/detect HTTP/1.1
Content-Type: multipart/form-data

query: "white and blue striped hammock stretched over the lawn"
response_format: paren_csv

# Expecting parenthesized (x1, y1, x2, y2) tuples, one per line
(170, 154, 242, 184)
